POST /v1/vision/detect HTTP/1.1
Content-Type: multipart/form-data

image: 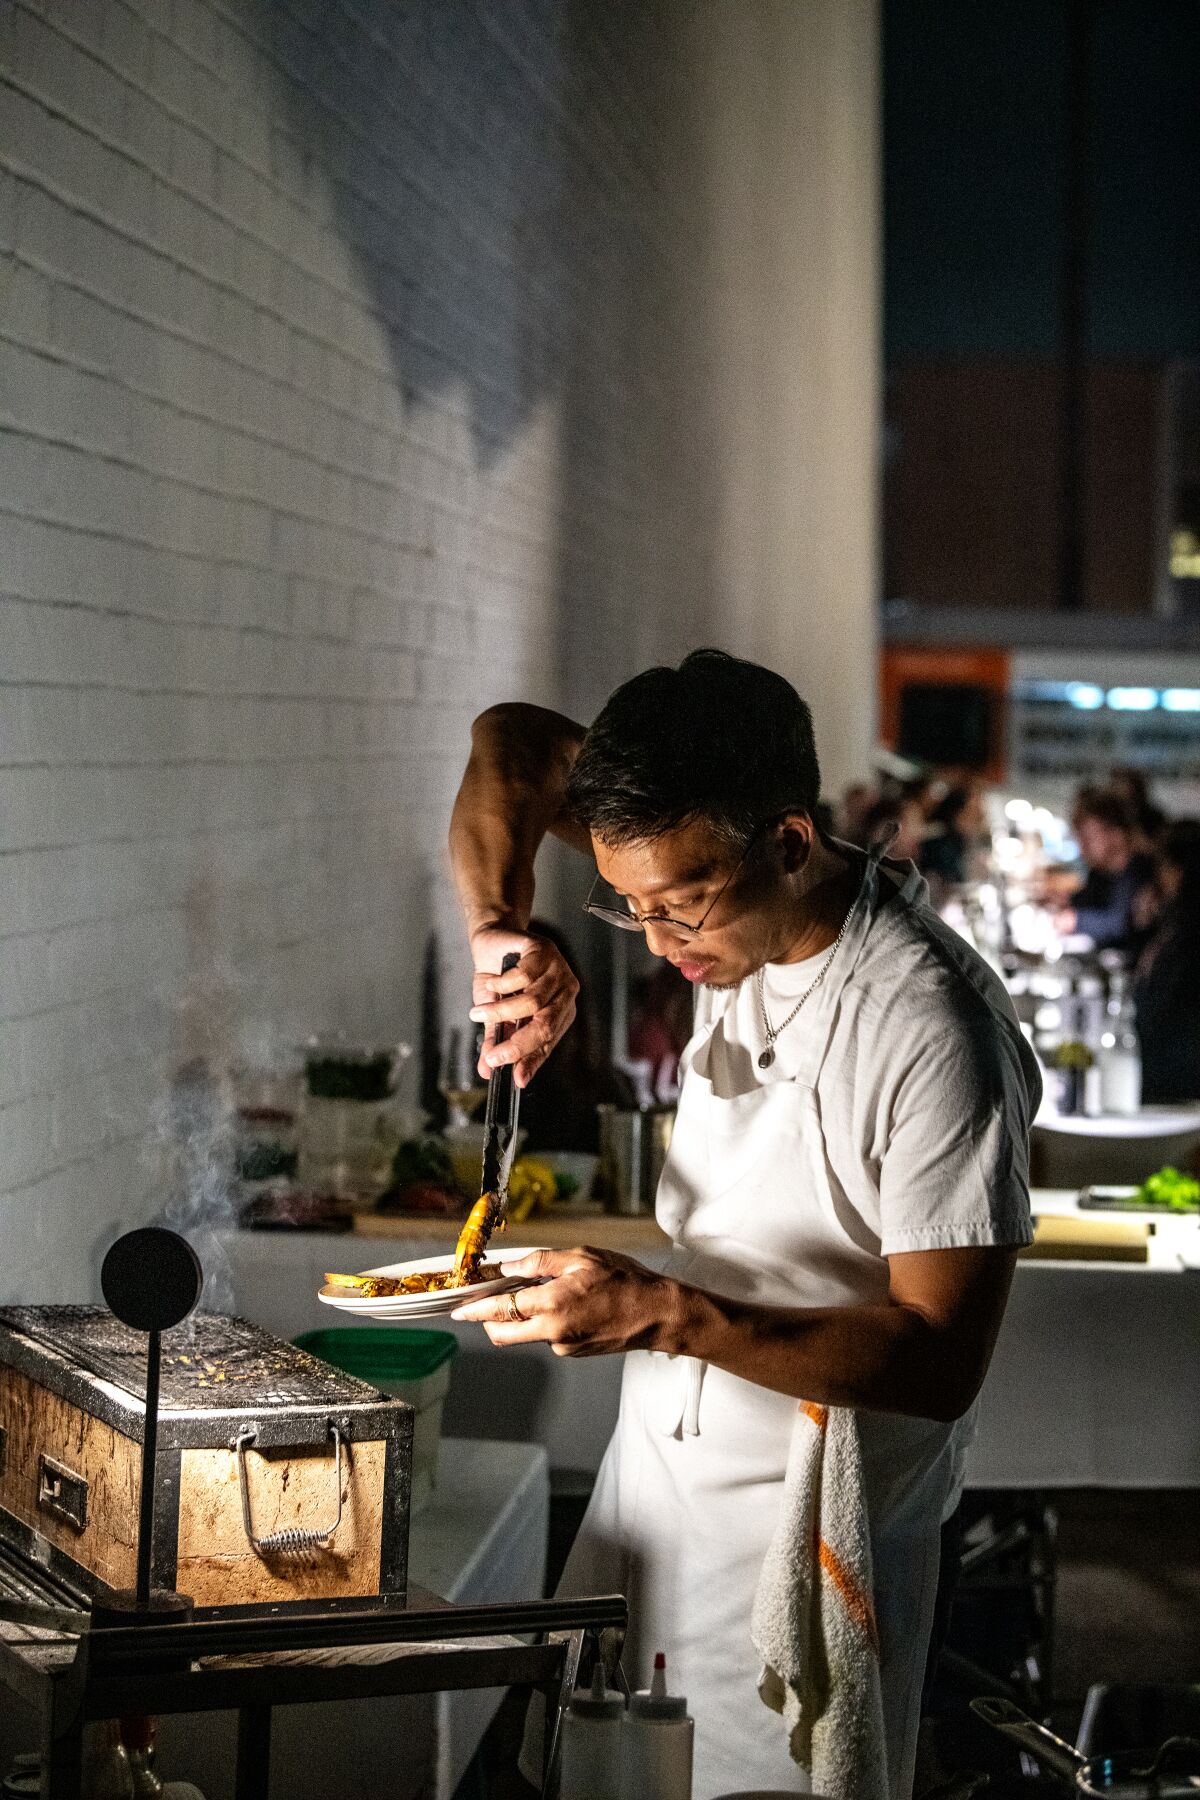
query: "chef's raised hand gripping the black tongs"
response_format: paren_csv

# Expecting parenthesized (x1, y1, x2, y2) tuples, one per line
(471, 925, 579, 1087)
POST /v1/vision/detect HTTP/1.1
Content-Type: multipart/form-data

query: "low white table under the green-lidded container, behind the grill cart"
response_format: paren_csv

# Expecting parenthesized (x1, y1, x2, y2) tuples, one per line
(158, 1438, 551, 1800)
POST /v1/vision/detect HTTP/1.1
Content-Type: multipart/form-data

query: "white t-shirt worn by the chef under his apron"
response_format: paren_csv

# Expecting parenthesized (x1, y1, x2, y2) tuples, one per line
(696, 864, 1042, 1256)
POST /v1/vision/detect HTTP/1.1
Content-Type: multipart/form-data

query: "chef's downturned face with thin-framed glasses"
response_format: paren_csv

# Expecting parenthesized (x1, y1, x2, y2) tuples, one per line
(592, 817, 811, 988)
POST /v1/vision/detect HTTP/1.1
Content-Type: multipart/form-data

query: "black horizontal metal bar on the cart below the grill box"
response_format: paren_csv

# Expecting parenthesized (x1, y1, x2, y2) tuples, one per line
(88, 1593, 630, 1674)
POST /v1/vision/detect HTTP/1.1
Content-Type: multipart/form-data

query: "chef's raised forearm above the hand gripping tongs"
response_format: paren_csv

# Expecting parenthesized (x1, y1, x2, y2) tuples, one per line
(450, 706, 583, 932)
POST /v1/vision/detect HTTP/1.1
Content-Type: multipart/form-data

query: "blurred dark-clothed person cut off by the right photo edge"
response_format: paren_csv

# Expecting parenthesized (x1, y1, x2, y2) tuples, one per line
(1133, 819, 1200, 1107)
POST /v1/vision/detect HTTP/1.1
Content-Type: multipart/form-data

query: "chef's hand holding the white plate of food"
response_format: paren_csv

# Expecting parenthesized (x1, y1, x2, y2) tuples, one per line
(452, 1249, 676, 1355)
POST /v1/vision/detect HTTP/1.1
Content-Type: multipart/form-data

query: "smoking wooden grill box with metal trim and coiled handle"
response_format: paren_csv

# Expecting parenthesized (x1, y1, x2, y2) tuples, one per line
(0, 1307, 412, 1609)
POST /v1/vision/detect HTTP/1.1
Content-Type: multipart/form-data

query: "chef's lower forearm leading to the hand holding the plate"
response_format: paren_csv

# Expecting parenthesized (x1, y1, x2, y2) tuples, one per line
(655, 1282, 990, 1420)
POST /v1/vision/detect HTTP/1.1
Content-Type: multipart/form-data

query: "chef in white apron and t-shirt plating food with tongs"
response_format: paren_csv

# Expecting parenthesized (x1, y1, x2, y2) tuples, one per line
(450, 650, 1040, 1800)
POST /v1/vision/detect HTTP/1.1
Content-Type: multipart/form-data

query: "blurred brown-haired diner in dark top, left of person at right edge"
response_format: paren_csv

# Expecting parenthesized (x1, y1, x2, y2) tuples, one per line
(1054, 787, 1155, 954)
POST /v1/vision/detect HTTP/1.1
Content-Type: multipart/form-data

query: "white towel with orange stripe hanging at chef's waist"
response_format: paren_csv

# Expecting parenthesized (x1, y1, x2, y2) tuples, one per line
(750, 1400, 889, 1800)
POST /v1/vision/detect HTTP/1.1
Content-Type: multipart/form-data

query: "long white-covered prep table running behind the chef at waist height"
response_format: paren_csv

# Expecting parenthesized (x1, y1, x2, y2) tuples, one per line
(227, 1190, 1200, 1489)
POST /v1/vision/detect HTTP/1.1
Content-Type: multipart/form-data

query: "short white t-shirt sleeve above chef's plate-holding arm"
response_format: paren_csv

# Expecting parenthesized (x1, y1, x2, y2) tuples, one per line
(880, 1004, 1040, 1256)
